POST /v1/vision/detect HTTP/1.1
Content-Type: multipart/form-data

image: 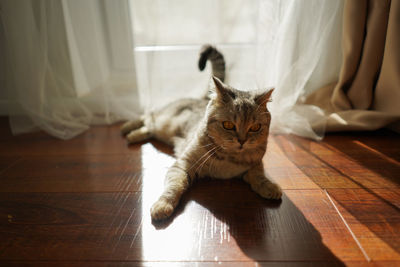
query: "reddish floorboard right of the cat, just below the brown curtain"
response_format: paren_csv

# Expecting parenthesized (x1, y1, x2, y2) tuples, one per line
(276, 136, 400, 188)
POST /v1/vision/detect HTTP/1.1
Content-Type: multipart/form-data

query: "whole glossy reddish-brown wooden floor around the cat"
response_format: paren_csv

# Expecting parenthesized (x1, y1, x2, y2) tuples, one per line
(0, 118, 400, 266)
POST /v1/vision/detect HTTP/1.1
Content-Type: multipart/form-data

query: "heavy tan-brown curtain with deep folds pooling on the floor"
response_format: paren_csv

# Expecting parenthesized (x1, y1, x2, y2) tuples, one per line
(306, 0, 400, 131)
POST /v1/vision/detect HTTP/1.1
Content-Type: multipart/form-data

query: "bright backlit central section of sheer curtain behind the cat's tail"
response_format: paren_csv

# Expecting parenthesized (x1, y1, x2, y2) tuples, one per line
(132, 0, 259, 109)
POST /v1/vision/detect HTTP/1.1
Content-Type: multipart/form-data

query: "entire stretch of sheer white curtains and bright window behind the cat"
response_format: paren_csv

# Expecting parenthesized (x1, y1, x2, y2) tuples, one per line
(0, 0, 343, 139)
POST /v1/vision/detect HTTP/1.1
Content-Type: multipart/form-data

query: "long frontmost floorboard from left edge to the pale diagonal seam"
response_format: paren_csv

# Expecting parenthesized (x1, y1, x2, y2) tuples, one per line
(0, 189, 363, 263)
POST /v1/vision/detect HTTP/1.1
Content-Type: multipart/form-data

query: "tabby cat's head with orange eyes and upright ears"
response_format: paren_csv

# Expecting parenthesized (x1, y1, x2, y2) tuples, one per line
(207, 77, 273, 153)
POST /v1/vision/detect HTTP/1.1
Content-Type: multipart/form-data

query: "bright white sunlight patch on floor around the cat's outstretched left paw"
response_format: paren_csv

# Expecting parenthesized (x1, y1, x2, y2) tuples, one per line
(141, 143, 245, 262)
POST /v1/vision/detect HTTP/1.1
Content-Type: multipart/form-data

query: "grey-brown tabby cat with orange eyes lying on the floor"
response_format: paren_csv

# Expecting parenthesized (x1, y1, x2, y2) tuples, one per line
(121, 45, 282, 221)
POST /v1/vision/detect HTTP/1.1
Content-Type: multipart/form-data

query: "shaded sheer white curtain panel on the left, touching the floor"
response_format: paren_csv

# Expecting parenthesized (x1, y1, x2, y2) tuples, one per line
(0, 0, 141, 139)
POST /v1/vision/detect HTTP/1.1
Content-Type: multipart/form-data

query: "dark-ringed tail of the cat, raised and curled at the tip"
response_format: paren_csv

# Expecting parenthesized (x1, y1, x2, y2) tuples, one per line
(199, 44, 225, 81)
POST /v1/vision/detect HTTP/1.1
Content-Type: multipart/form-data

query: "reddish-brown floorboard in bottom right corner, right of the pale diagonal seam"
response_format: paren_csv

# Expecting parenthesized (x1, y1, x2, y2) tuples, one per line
(328, 188, 400, 261)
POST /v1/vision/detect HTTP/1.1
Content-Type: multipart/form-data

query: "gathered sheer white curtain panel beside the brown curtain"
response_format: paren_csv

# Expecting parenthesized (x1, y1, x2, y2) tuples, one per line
(256, 0, 343, 140)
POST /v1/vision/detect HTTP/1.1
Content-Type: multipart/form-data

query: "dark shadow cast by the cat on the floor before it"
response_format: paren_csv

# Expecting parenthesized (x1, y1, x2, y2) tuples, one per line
(153, 179, 344, 266)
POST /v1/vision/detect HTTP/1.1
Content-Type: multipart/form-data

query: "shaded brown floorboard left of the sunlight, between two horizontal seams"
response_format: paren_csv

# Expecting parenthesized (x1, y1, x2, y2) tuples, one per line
(0, 155, 142, 192)
